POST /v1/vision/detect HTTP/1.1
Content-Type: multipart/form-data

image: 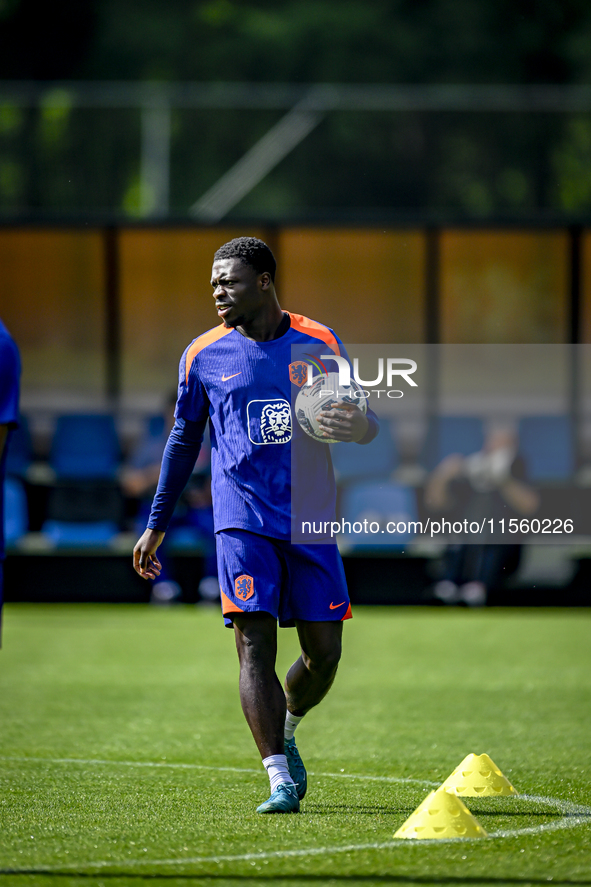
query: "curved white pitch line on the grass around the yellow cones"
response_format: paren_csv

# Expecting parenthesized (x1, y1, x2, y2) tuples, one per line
(0, 756, 591, 874)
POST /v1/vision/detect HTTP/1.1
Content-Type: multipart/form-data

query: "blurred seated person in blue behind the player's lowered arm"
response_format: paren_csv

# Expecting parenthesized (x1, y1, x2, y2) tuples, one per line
(120, 391, 220, 604)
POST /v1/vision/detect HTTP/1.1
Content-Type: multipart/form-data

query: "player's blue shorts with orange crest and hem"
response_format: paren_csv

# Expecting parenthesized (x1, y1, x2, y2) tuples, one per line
(216, 530, 351, 627)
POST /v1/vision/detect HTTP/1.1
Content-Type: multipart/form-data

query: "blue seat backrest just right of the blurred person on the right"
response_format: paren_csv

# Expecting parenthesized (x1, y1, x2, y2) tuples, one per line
(519, 416, 575, 481)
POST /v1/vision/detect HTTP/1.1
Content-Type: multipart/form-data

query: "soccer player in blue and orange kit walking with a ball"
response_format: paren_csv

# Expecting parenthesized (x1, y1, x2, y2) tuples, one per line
(134, 237, 378, 813)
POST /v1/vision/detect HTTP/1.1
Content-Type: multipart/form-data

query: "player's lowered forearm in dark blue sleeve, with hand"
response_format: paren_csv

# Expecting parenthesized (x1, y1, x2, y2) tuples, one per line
(133, 418, 207, 579)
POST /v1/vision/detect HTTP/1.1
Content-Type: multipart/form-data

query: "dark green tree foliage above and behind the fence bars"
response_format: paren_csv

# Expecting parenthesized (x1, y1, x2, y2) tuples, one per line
(0, 0, 591, 218)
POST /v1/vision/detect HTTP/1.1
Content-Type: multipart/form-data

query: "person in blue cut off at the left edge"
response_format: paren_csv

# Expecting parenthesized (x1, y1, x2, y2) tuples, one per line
(0, 320, 21, 644)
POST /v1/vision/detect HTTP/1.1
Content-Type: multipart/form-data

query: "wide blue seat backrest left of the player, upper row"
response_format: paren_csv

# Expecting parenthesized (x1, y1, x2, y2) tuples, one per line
(49, 414, 121, 478)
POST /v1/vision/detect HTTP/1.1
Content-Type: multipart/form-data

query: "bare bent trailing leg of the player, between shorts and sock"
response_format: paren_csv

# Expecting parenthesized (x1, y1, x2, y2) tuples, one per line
(285, 620, 343, 717)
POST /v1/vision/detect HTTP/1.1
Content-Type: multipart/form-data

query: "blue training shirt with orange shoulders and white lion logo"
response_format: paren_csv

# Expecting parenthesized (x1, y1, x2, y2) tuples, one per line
(148, 313, 379, 539)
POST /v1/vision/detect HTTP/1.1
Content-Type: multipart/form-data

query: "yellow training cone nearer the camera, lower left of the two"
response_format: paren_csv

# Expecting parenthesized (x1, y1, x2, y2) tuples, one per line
(394, 788, 486, 839)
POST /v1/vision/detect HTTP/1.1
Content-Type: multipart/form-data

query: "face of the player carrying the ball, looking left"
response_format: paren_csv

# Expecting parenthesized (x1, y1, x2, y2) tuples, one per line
(211, 259, 270, 327)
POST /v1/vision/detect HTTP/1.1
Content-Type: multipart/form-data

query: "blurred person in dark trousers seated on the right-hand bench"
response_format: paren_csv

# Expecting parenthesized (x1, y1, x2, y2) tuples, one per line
(425, 428, 540, 607)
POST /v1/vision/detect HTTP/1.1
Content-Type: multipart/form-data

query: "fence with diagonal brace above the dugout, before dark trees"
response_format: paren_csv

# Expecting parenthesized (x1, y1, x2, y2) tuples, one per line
(0, 81, 591, 222)
